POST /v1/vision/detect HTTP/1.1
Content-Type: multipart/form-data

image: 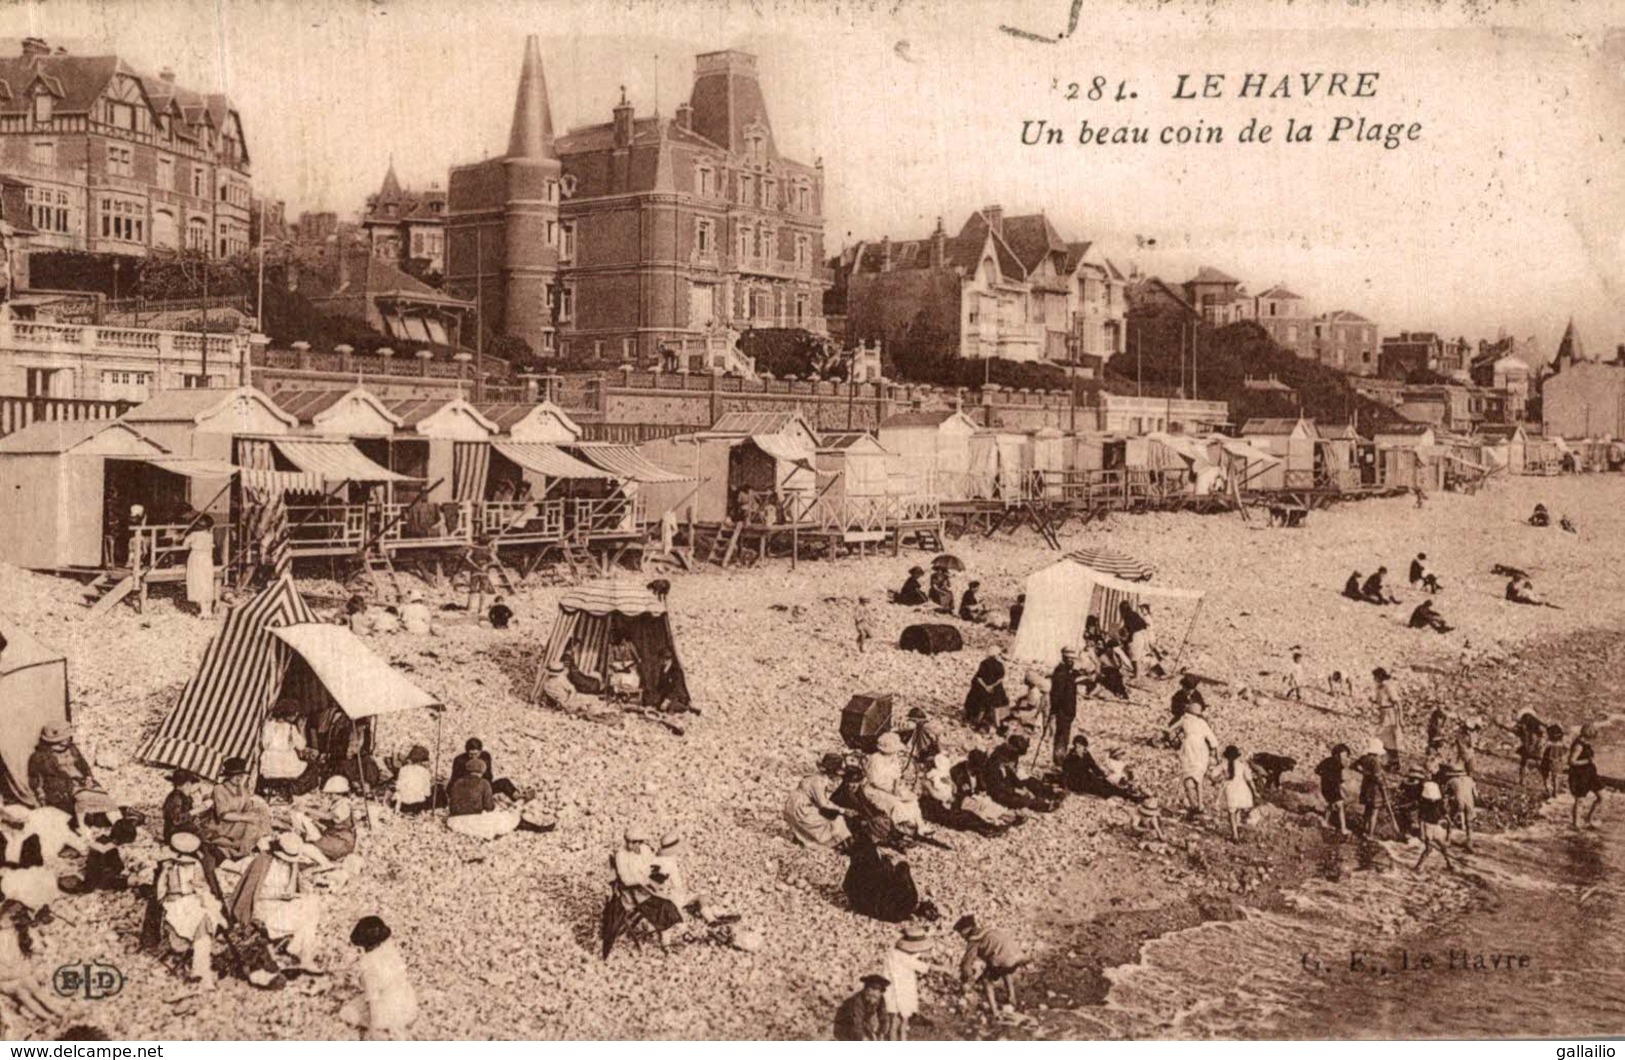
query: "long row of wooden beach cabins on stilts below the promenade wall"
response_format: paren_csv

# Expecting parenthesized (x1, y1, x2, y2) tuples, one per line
(0, 387, 1563, 606)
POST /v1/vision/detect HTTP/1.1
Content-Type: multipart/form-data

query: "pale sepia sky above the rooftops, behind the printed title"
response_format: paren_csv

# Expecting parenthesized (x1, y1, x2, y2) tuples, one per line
(0, 0, 1625, 356)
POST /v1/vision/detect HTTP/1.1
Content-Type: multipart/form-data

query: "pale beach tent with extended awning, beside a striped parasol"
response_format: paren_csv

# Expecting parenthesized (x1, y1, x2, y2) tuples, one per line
(1011, 559, 1203, 665)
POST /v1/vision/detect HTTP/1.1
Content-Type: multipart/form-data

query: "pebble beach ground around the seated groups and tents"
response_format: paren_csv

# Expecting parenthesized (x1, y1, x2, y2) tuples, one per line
(0, 476, 1625, 1037)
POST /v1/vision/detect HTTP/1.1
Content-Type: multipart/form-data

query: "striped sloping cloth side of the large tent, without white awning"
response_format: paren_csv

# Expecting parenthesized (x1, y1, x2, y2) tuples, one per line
(140, 577, 317, 779)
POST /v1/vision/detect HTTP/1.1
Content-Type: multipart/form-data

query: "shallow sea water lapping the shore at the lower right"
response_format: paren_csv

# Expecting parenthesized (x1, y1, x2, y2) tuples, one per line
(1102, 695, 1625, 1039)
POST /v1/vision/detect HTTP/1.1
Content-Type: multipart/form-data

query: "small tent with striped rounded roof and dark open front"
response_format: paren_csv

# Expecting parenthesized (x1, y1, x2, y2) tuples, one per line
(536, 579, 683, 702)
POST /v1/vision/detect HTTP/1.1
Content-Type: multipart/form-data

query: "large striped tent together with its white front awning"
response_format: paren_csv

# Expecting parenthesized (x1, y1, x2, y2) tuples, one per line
(140, 577, 439, 779)
